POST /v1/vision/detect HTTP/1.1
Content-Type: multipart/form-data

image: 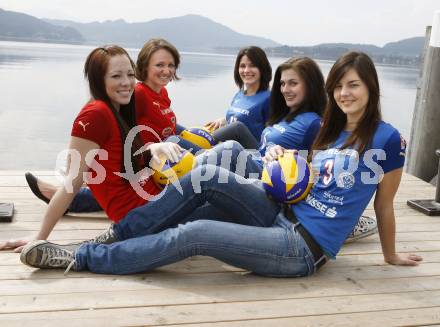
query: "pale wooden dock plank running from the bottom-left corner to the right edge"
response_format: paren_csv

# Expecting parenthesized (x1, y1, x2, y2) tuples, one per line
(0, 291, 440, 326)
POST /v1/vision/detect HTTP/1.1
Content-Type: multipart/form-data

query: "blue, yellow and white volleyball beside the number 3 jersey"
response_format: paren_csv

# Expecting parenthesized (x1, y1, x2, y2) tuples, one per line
(261, 151, 313, 203)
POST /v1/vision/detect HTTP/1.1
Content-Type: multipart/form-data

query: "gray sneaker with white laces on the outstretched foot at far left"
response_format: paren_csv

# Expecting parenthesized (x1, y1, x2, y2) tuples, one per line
(20, 240, 78, 273)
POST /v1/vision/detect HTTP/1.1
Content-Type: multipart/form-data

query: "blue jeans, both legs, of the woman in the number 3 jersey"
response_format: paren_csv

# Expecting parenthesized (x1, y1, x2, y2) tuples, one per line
(74, 165, 315, 277)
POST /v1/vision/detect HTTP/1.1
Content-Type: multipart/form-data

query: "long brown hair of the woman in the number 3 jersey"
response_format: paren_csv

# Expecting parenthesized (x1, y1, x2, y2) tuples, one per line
(312, 51, 382, 152)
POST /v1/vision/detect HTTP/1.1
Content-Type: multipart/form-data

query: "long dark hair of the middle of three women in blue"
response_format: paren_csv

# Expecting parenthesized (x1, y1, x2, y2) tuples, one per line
(267, 57, 327, 126)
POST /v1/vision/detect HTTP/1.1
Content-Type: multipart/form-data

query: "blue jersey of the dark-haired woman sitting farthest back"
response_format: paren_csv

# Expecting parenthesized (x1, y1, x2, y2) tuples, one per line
(226, 91, 270, 140)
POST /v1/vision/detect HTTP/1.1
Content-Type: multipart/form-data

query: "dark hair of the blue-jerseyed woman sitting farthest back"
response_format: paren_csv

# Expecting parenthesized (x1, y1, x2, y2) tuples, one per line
(234, 46, 272, 93)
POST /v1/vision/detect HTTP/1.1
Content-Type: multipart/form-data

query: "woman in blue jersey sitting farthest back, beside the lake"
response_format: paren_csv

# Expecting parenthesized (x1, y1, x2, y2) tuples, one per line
(205, 46, 272, 149)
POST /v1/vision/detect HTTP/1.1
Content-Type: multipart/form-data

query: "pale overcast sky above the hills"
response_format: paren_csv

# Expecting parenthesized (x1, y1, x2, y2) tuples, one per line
(0, 0, 440, 46)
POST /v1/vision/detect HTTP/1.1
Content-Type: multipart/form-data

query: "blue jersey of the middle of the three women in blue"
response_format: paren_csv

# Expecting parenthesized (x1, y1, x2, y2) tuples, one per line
(258, 112, 321, 157)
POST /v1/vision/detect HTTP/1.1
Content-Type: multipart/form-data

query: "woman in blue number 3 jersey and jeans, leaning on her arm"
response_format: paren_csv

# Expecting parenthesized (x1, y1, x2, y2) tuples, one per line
(20, 52, 422, 277)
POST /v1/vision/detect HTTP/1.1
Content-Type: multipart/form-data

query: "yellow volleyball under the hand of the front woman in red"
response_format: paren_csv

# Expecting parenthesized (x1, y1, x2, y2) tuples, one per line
(153, 150, 196, 188)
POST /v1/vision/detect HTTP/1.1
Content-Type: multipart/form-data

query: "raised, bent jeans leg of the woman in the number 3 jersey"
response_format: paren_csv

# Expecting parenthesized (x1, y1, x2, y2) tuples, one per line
(113, 165, 272, 240)
